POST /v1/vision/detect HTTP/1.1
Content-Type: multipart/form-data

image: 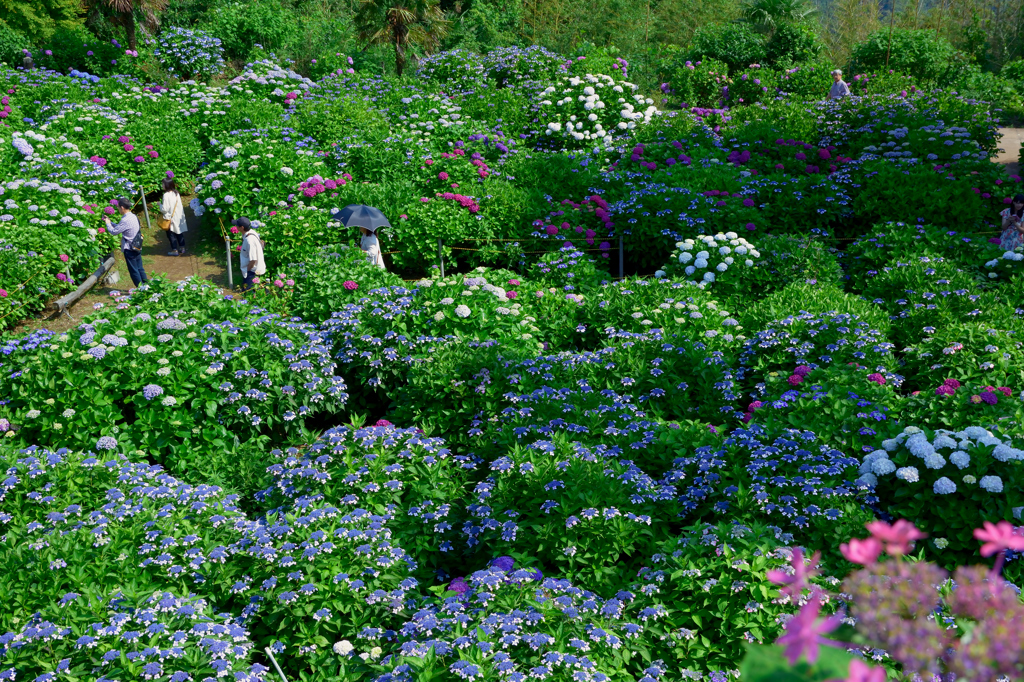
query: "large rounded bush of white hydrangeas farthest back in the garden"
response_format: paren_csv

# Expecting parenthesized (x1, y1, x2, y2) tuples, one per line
(539, 74, 658, 150)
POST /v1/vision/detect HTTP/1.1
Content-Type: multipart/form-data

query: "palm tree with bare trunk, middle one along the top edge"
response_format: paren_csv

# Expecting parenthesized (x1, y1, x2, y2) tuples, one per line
(355, 0, 449, 77)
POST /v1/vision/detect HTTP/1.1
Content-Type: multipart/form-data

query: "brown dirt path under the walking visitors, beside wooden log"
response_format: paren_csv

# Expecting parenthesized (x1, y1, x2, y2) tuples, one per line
(13, 197, 227, 333)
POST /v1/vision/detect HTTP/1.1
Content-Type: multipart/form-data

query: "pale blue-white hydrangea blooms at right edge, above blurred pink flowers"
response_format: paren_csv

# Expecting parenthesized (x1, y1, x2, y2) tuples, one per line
(857, 426, 1024, 495)
